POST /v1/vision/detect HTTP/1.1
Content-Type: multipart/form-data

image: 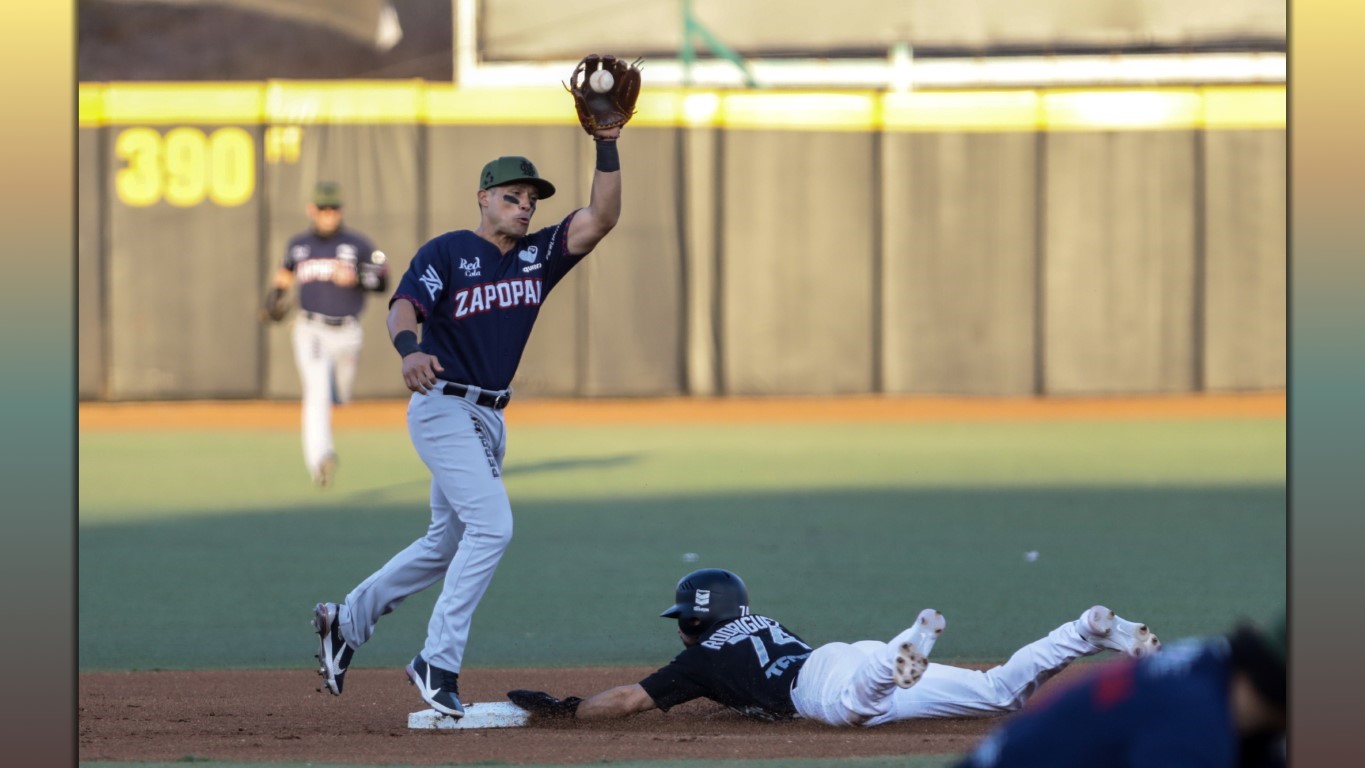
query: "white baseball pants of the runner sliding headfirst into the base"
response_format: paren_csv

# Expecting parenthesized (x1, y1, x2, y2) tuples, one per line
(792, 621, 1102, 727)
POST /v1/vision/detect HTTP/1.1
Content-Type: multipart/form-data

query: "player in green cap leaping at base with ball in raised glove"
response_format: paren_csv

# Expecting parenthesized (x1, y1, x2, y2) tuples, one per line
(313, 55, 640, 718)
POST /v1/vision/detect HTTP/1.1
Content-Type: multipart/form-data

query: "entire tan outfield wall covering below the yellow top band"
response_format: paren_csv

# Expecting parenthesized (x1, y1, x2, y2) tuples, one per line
(78, 87, 1287, 400)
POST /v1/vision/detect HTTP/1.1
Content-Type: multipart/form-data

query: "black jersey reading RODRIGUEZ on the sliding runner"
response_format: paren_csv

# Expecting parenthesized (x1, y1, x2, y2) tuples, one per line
(640, 615, 811, 720)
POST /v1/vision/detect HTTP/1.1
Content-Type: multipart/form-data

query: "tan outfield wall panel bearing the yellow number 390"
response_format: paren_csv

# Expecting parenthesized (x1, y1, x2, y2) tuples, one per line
(105, 124, 262, 400)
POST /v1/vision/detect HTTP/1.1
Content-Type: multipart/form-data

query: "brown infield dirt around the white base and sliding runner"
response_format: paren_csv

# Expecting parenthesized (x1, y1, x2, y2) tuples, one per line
(78, 664, 1095, 765)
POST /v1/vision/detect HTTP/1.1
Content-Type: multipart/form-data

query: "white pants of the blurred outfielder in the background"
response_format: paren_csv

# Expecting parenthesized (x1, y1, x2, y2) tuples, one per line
(293, 316, 363, 475)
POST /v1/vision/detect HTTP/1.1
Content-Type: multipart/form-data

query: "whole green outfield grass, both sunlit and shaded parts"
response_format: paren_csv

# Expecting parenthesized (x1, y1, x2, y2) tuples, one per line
(78, 420, 1286, 670)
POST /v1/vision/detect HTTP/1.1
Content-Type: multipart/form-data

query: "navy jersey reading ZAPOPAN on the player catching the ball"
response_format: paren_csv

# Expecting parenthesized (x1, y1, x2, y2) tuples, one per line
(389, 211, 583, 390)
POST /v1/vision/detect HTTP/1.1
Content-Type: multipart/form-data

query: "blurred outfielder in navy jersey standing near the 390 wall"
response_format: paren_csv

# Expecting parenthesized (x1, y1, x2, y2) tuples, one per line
(263, 181, 389, 487)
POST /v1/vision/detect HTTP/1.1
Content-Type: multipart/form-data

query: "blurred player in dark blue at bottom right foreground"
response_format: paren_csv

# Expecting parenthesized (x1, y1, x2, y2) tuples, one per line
(960, 615, 1289, 768)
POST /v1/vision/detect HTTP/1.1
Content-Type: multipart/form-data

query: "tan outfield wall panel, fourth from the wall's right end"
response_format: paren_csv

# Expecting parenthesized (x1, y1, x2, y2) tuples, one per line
(719, 131, 876, 394)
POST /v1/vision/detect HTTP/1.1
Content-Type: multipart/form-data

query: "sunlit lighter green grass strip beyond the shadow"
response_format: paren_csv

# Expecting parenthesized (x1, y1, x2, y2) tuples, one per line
(79, 420, 1286, 527)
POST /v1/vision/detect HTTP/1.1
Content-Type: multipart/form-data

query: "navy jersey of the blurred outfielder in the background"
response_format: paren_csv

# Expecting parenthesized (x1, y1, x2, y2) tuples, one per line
(284, 229, 389, 318)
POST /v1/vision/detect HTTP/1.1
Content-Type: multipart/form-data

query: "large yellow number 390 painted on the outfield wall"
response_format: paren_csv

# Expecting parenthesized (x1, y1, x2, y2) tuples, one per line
(113, 128, 255, 207)
